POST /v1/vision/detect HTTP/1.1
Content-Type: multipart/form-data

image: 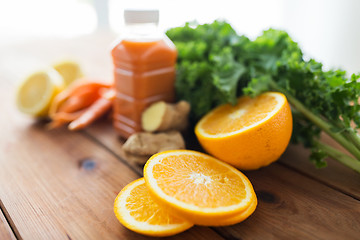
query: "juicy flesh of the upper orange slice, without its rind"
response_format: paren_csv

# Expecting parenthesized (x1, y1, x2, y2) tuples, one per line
(153, 155, 246, 208)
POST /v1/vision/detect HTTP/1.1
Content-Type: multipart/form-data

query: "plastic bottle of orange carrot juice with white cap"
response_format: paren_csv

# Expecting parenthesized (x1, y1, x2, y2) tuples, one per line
(111, 10, 177, 138)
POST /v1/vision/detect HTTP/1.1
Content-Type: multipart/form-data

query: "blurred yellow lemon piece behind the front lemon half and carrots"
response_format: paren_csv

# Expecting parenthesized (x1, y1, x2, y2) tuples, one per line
(53, 61, 83, 86)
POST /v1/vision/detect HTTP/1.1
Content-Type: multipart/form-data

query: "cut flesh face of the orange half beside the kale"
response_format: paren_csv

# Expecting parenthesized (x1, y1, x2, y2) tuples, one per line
(202, 95, 277, 135)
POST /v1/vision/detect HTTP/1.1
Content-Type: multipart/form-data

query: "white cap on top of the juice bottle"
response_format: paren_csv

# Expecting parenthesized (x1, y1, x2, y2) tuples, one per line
(124, 9, 159, 24)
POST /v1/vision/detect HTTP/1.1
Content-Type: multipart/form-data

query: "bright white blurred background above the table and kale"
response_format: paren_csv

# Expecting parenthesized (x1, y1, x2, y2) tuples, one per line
(0, 0, 360, 72)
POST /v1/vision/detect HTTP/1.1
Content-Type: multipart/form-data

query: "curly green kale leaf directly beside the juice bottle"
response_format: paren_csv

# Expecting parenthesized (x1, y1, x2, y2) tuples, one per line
(166, 21, 246, 121)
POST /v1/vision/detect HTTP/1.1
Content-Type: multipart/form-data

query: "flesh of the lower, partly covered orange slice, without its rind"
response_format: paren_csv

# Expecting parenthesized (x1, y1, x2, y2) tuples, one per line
(126, 182, 184, 225)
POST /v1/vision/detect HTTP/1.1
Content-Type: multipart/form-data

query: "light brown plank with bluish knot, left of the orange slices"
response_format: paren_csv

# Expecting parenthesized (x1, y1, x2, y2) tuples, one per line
(0, 66, 222, 239)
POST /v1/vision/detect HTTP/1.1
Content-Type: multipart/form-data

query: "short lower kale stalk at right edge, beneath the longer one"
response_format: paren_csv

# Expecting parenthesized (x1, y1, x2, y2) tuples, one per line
(314, 141, 360, 173)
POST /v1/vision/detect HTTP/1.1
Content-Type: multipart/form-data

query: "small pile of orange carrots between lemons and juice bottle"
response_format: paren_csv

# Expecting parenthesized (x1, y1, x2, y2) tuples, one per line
(48, 78, 115, 130)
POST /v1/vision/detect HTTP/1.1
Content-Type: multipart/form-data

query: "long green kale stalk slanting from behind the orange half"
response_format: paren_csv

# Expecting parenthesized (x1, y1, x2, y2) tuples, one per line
(270, 81, 360, 160)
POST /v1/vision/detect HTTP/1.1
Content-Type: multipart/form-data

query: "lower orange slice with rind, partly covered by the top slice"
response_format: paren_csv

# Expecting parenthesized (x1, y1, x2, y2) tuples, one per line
(114, 178, 193, 237)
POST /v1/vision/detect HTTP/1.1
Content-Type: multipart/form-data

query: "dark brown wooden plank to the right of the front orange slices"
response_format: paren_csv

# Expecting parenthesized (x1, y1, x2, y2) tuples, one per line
(217, 163, 360, 240)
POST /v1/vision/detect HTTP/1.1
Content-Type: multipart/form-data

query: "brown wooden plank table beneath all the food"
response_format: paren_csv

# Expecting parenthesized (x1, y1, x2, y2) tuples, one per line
(0, 32, 360, 240)
